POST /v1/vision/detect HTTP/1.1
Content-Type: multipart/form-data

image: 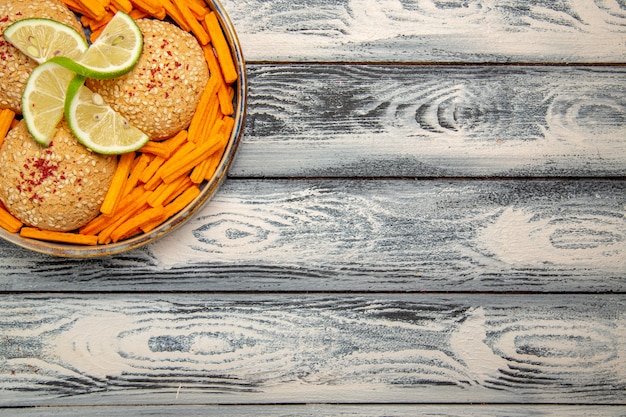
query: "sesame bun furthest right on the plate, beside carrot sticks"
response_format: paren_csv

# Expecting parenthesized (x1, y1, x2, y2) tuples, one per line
(86, 19, 209, 139)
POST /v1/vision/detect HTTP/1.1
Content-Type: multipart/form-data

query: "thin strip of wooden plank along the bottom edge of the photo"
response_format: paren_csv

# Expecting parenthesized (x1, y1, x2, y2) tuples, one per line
(0, 404, 626, 417)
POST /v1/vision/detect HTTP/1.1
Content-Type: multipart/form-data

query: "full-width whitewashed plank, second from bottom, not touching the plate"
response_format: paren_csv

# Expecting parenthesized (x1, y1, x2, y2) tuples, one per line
(0, 294, 626, 407)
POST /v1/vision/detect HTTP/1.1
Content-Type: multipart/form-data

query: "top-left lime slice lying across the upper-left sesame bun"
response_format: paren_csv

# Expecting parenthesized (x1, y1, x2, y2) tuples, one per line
(4, 18, 88, 64)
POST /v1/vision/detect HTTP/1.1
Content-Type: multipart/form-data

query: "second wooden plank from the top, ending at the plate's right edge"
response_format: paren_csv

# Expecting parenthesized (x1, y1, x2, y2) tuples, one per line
(230, 65, 626, 178)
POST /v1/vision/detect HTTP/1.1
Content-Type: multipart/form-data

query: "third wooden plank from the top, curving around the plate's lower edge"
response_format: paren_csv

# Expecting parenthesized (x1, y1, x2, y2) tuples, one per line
(0, 180, 626, 292)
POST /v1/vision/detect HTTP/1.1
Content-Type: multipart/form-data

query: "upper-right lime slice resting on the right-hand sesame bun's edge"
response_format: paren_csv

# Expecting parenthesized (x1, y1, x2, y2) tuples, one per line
(52, 11, 143, 80)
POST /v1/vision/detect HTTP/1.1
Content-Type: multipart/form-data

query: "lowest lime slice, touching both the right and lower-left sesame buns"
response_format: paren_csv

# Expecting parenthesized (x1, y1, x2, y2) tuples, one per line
(65, 75, 150, 154)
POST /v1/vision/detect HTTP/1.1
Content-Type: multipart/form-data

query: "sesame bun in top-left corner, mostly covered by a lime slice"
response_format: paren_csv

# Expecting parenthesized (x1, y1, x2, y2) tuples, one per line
(0, 0, 84, 114)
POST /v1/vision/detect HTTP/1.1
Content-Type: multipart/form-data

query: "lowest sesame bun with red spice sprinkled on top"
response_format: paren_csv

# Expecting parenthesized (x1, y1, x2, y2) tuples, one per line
(0, 121, 117, 231)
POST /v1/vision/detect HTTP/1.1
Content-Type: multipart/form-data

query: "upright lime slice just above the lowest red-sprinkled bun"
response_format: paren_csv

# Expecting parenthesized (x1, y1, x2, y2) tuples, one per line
(22, 62, 74, 146)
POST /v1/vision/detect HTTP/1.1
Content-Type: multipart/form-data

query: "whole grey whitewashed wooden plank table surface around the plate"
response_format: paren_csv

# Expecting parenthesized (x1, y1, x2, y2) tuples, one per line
(0, 0, 626, 416)
